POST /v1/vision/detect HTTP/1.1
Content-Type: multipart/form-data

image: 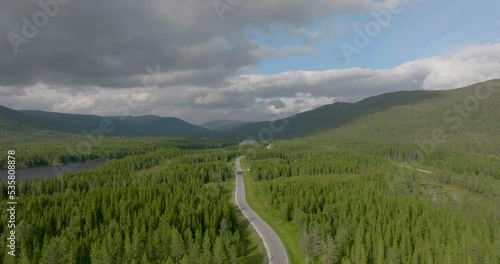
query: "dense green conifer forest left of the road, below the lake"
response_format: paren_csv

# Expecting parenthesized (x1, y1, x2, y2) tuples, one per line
(0, 148, 258, 264)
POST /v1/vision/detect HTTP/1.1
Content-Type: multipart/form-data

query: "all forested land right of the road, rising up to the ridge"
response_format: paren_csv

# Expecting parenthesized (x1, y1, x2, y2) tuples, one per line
(238, 80, 500, 263)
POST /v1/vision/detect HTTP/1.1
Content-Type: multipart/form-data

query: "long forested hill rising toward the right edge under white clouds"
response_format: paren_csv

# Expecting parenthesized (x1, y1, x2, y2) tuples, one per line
(227, 80, 500, 140)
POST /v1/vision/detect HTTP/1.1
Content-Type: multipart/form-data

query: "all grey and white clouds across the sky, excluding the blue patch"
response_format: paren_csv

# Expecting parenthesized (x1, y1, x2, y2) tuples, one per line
(0, 0, 500, 126)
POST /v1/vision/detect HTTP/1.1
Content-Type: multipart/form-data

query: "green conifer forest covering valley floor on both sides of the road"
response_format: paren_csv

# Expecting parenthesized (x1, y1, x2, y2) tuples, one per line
(0, 139, 500, 263)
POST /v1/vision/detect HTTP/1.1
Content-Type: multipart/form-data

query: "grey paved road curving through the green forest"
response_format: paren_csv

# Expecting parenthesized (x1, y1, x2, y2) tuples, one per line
(234, 157, 289, 264)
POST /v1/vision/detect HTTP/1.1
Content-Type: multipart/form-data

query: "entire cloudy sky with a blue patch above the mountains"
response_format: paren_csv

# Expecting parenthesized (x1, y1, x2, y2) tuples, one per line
(0, 0, 500, 124)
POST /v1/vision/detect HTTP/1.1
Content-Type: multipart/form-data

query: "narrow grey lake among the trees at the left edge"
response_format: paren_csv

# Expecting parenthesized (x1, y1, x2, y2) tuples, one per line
(0, 161, 104, 182)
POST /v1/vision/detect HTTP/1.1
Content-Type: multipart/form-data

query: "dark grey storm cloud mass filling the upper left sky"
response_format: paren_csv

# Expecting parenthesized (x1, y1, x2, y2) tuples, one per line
(0, 0, 394, 88)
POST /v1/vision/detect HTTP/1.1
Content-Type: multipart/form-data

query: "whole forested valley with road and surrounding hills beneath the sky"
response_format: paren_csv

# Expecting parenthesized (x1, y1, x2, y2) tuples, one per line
(0, 81, 500, 264)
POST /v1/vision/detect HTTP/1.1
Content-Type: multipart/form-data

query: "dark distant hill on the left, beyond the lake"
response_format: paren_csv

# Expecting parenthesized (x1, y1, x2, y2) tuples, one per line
(0, 107, 216, 137)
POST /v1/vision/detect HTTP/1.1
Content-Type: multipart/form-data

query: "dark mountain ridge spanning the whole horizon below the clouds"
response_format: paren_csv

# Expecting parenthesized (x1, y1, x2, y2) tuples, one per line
(0, 80, 500, 140)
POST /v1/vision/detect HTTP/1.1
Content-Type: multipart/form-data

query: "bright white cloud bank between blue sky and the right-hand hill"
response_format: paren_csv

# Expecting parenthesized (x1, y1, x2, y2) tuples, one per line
(225, 43, 500, 99)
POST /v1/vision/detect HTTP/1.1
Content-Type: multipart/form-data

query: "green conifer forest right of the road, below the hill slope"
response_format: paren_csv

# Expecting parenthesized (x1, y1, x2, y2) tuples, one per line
(247, 143, 500, 263)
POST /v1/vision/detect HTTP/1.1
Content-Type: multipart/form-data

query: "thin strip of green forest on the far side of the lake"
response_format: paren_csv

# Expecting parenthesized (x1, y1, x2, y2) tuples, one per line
(0, 136, 231, 168)
